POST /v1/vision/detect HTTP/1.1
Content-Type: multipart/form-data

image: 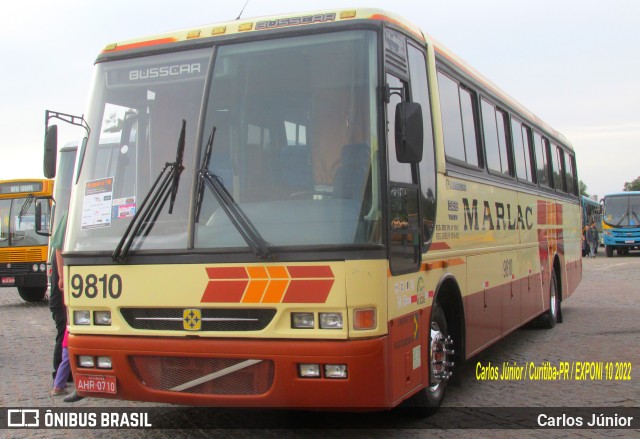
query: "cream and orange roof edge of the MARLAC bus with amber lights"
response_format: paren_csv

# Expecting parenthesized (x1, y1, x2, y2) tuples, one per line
(97, 8, 573, 151)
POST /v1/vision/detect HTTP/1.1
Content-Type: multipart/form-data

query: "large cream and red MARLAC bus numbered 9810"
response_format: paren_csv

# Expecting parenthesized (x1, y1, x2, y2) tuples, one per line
(45, 9, 582, 413)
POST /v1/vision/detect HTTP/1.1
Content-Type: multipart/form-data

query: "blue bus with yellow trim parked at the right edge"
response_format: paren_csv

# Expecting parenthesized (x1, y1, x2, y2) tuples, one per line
(602, 191, 640, 258)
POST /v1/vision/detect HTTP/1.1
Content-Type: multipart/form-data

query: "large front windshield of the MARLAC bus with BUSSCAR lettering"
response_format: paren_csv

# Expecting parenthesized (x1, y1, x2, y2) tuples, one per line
(66, 31, 382, 252)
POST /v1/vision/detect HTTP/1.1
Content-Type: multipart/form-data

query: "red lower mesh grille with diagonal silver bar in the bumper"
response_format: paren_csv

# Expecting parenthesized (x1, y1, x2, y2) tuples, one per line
(129, 355, 275, 395)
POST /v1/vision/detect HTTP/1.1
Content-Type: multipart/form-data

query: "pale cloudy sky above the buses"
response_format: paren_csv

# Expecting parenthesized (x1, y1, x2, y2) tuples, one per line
(0, 0, 640, 197)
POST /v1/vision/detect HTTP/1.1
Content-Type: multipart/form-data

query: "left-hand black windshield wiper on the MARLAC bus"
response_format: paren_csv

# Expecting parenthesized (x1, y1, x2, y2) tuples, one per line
(111, 119, 187, 262)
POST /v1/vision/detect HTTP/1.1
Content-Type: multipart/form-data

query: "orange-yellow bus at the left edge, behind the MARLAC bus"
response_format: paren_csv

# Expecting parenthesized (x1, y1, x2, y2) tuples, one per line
(0, 179, 53, 302)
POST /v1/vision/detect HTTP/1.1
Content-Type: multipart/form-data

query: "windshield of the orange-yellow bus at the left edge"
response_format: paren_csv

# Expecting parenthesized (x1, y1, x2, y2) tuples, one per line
(0, 197, 48, 247)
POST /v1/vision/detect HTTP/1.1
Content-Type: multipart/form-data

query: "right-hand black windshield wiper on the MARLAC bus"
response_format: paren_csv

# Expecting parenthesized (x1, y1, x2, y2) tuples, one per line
(195, 127, 273, 259)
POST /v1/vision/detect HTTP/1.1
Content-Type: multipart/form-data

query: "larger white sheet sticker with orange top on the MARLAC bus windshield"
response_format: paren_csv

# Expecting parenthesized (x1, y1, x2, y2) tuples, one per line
(81, 177, 113, 229)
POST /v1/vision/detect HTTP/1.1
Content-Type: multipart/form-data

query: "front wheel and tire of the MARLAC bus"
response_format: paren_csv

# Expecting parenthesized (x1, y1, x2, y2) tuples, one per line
(402, 302, 454, 417)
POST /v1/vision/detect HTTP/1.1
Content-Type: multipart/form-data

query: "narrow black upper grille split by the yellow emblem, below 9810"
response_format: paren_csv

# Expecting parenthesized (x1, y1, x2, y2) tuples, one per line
(120, 308, 276, 332)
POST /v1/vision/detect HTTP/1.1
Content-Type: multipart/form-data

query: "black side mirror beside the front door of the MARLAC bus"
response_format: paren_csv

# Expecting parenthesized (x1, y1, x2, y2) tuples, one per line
(395, 102, 424, 163)
